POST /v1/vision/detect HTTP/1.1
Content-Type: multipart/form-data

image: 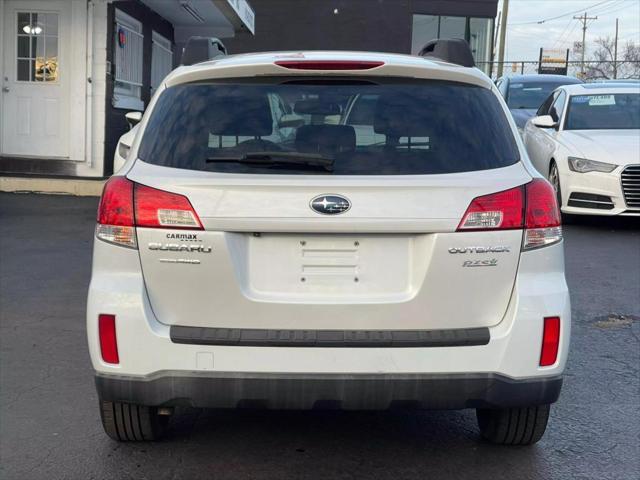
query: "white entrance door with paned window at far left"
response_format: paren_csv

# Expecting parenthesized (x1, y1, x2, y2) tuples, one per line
(2, 0, 71, 158)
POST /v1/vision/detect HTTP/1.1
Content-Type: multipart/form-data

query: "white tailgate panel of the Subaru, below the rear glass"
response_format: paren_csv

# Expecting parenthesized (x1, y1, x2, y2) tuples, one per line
(131, 163, 530, 330)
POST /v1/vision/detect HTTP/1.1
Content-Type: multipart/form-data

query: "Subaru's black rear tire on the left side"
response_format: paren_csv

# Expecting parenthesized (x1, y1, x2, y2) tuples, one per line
(100, 400, 169, 442)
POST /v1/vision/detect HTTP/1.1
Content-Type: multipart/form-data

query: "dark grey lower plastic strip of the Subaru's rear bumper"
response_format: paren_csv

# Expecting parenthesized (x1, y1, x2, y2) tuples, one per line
(96, 372, 562, 410)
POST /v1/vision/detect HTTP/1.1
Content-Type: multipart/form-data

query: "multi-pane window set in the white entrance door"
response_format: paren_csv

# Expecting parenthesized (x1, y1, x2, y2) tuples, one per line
(16, 12, 59, 82)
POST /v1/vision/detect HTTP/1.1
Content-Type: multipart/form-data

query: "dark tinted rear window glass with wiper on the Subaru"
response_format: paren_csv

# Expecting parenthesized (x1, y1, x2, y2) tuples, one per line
(138, 78, 519, 175)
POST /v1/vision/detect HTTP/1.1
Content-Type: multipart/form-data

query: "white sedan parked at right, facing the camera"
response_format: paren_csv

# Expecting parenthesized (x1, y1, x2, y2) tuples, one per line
(523, 83, 640, 216)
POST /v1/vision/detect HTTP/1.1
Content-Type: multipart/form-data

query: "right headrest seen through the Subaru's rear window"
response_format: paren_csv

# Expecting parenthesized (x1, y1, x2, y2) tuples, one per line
(373, 94, 438, 137)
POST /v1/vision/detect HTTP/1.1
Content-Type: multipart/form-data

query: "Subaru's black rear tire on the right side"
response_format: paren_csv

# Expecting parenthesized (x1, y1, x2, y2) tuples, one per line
(476, 405, 550, 445)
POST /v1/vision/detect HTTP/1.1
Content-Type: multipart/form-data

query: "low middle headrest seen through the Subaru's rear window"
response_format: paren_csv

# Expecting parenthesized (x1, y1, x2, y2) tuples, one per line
(295, 125, 356, 154)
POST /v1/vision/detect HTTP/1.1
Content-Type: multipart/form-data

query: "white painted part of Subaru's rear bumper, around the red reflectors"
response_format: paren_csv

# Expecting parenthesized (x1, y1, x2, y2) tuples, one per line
(87, 241, 571, 382)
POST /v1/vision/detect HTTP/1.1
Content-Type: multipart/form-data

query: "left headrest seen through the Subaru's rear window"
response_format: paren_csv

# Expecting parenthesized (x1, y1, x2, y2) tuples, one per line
(206, 93, 273, 137)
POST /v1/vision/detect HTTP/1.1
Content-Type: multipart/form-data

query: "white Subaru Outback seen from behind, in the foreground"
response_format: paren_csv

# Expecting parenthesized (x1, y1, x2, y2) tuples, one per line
(87, 43, 570, 445)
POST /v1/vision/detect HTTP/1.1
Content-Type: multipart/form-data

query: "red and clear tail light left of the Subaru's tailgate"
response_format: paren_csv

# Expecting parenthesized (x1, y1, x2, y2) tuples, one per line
(96, 177, 203, 248)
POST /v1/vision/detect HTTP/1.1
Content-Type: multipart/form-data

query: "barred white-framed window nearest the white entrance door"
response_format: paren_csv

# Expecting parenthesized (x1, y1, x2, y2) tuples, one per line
(113, 9, 144, 110)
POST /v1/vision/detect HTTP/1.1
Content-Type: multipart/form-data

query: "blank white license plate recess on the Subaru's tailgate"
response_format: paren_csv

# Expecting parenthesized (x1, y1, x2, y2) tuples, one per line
(248, 234, 413, 302)
